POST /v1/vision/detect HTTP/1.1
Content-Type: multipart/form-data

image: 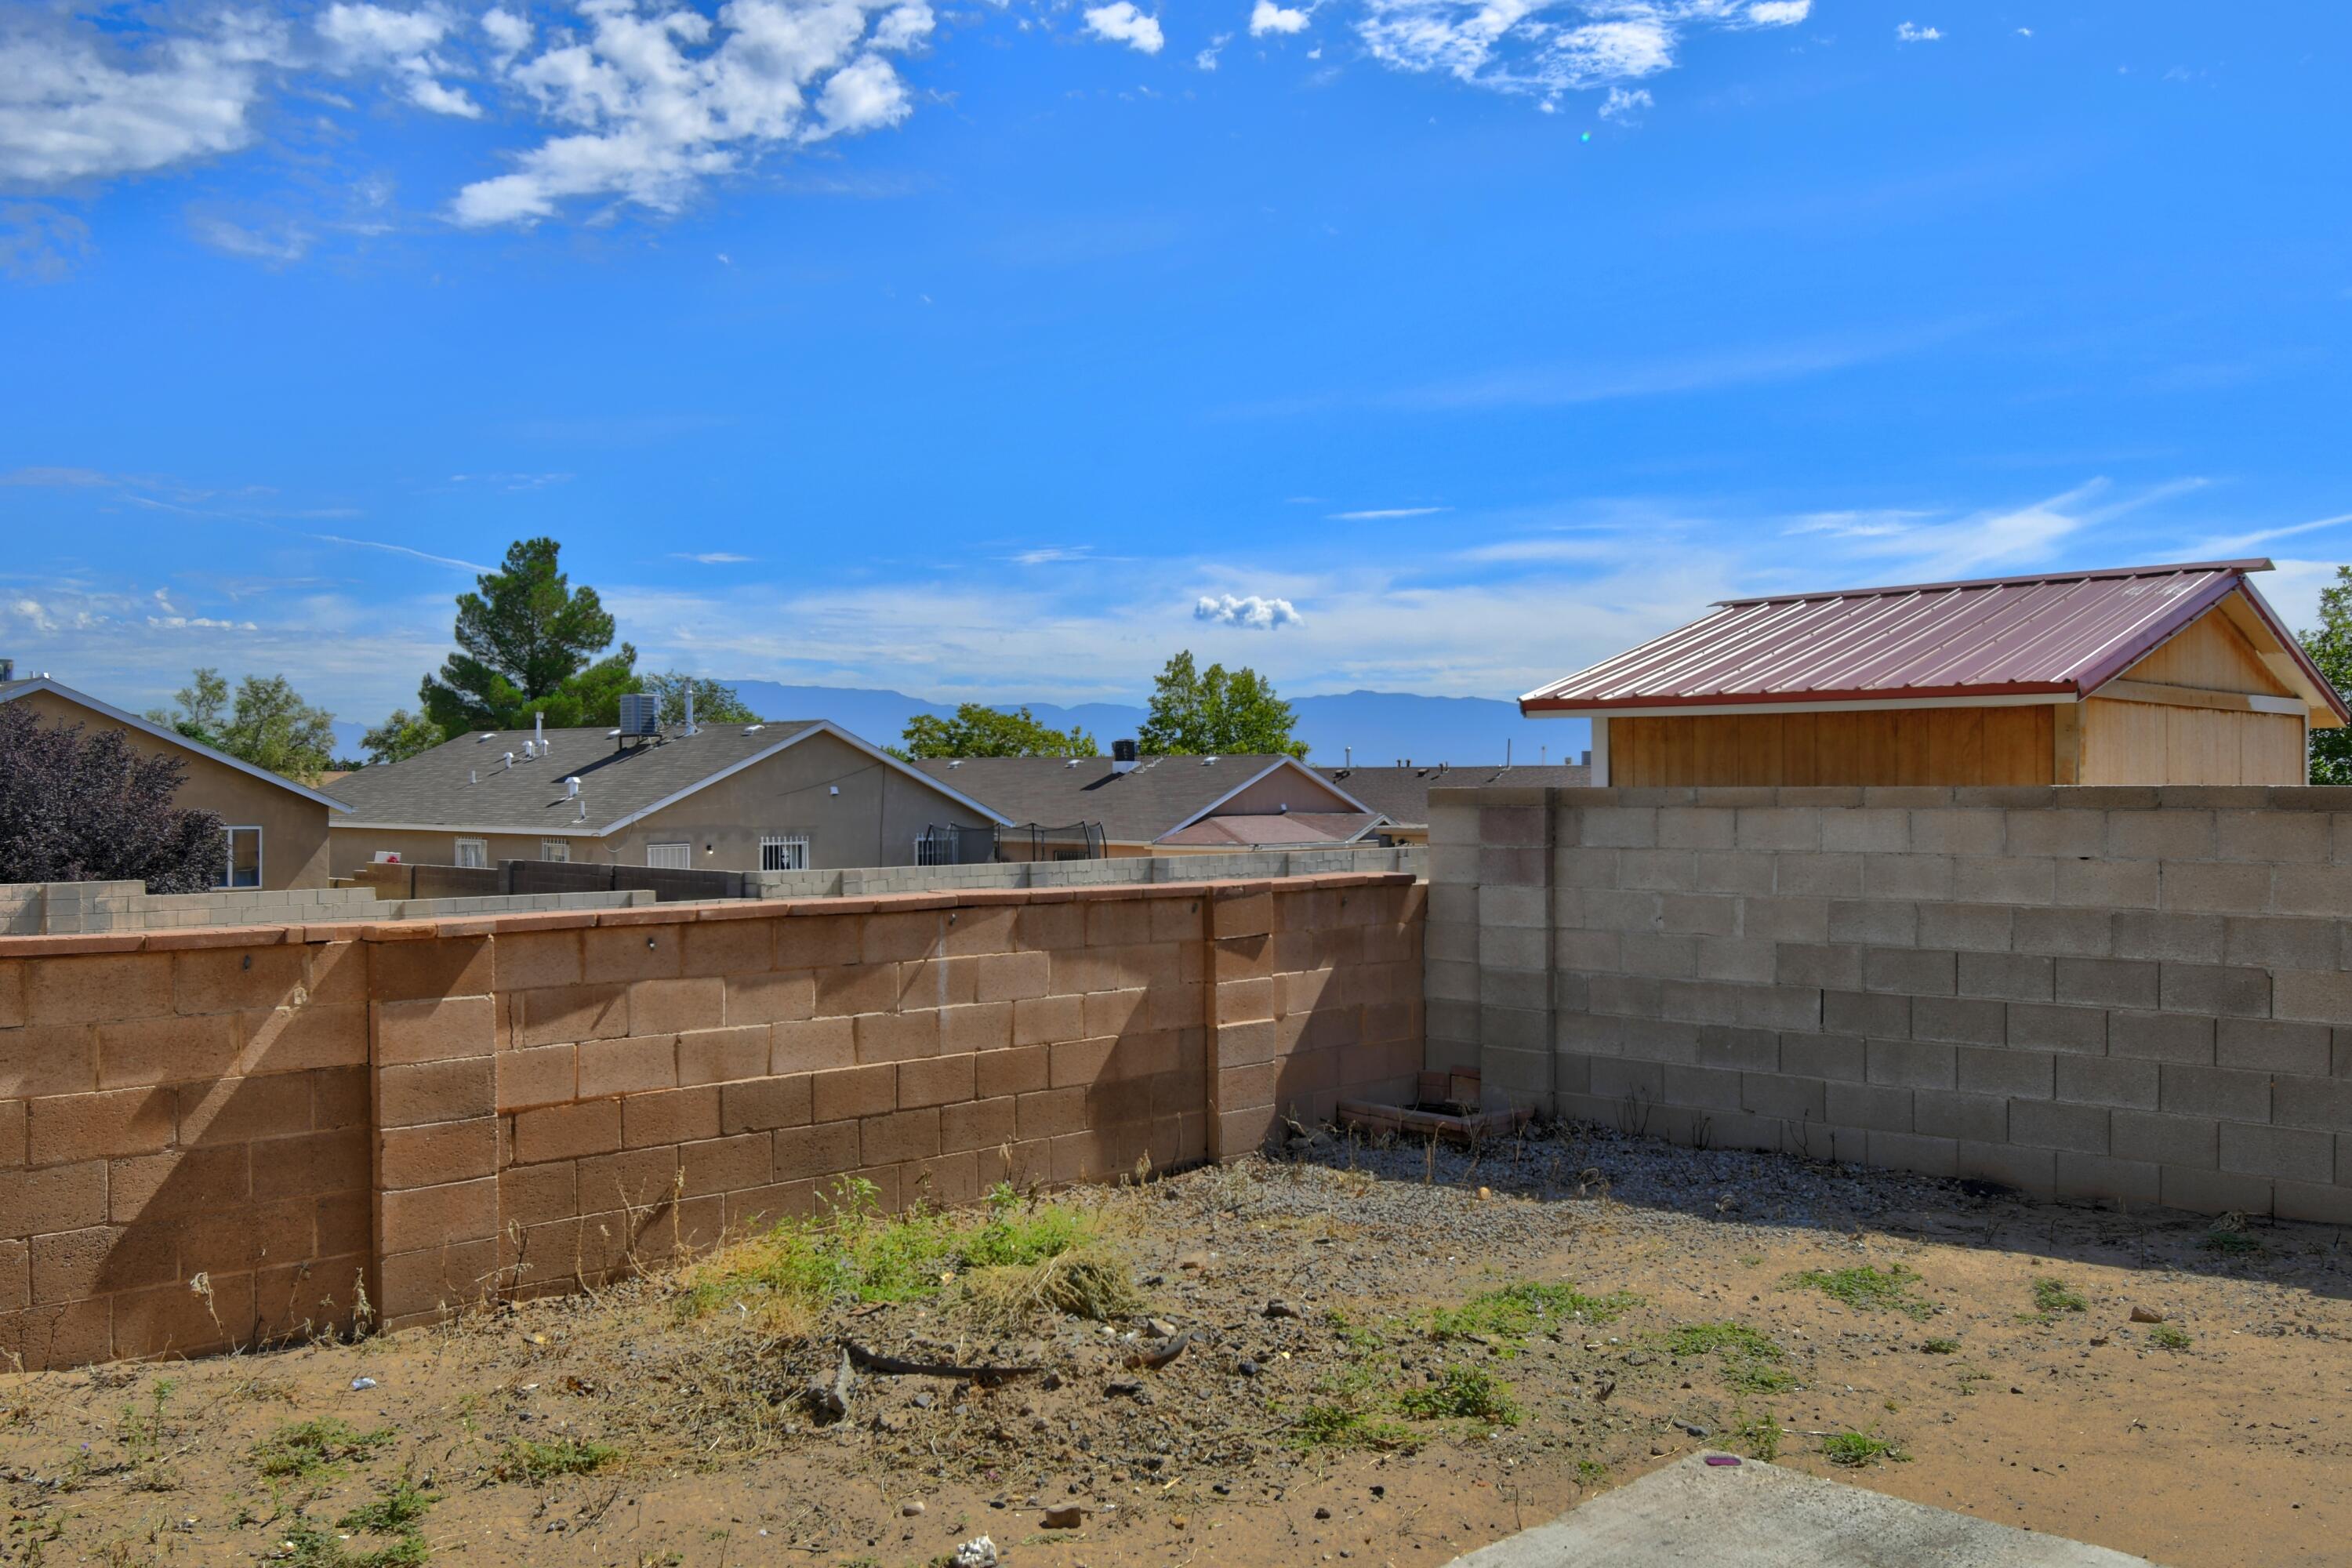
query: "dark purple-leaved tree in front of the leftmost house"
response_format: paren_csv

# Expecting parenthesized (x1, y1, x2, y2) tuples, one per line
(0, 703, 228, 893)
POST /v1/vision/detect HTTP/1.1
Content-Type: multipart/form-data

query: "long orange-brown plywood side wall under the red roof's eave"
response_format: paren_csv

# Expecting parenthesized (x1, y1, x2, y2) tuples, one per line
(1609, 703, 2053, 787)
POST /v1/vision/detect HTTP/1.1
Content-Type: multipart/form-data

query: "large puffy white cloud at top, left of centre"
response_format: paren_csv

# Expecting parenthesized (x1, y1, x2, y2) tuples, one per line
(449, 0, 934, 228)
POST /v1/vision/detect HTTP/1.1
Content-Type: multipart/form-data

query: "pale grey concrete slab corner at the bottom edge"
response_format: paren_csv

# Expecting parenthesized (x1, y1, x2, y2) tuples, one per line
(1449, 1455, 2154, 1568)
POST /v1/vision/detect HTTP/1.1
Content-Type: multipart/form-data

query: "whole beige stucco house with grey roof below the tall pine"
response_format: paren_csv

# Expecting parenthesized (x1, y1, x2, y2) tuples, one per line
(327, 720, 1007, 877)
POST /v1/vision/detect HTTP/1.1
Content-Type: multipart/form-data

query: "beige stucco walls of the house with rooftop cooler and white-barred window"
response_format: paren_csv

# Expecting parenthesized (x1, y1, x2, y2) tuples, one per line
(334, 736, 988, 877)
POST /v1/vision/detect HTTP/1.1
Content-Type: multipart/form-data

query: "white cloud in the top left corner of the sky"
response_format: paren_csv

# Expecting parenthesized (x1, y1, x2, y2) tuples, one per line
(0, 14, 287, 186)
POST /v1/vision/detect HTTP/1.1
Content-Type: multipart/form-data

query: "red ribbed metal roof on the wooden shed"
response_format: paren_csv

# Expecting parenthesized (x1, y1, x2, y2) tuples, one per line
(1519, 560, 2352, 717)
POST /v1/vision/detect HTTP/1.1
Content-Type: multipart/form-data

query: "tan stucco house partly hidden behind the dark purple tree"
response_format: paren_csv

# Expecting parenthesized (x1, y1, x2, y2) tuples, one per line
(0, 675, 348, 891)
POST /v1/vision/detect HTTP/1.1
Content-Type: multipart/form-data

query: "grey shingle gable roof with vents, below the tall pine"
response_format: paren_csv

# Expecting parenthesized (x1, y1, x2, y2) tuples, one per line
(327, 720, 1007, 839)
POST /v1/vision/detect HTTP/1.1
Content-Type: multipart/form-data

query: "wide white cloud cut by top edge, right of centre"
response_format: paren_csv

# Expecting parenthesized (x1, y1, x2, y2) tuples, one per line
(1357, 0, 1811, 103)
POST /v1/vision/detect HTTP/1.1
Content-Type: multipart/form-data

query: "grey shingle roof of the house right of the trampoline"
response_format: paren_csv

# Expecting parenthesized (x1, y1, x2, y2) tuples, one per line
(915, 757, 1371, 844)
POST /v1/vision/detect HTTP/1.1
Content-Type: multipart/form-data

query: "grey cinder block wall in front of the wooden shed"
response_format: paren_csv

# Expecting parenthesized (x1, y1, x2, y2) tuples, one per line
(1428, 787, 2352, 1222)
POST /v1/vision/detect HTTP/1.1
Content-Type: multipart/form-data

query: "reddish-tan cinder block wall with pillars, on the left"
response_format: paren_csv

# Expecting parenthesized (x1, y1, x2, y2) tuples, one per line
(0, 872, 1423, 1366)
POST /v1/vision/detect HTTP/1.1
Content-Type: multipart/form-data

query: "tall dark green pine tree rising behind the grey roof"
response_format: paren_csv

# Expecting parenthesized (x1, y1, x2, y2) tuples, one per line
(419, 539, 637, 736)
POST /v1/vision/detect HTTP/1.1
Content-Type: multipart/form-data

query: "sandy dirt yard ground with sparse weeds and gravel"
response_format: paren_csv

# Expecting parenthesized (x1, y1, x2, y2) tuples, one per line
(0, 1126, 2352, 1568)
